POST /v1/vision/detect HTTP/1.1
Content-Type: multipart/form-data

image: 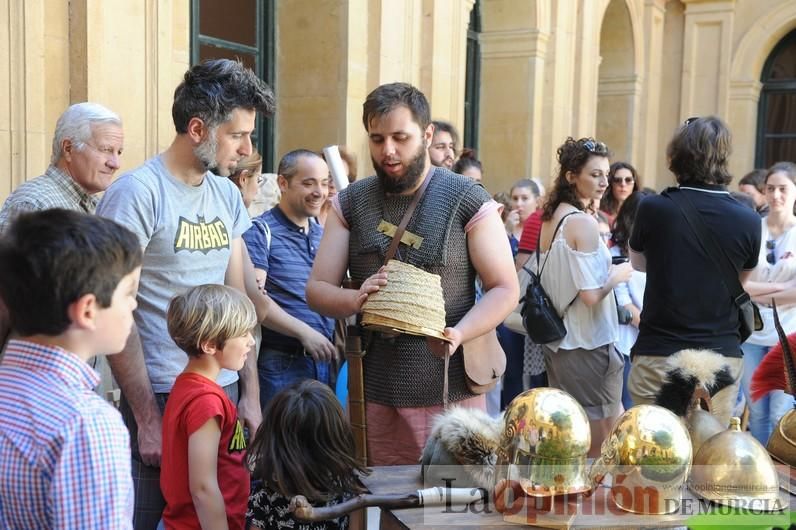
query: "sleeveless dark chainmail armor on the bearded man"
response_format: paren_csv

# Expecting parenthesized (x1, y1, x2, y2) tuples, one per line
(339, 168, 491, 407)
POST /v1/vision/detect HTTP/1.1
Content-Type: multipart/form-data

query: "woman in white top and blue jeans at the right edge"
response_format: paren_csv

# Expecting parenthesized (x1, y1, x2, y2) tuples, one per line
(741, 162, 796, 445)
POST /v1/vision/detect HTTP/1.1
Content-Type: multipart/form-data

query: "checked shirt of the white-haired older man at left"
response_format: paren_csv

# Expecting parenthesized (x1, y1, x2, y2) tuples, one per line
(0, 166, 98, 234)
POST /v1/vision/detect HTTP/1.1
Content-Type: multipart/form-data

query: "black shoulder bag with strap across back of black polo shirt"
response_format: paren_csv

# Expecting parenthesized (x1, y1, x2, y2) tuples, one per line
(663, 188, 763, 343)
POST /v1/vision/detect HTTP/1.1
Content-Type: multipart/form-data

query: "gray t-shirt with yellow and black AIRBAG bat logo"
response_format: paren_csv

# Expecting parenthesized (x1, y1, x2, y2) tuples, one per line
(97, 156, 251, 392)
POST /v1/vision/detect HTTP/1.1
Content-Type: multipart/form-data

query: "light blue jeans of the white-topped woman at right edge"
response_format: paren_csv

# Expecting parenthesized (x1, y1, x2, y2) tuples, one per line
(741, 343, 793, 445)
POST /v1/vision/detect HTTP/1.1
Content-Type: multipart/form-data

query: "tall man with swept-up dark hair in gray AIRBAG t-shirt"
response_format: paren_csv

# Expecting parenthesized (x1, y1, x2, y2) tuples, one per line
(97, 59, 274, 529)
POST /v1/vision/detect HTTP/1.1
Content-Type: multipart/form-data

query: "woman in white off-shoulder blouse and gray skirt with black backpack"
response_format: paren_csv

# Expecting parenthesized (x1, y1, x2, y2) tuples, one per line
(539, 138, 633, 456)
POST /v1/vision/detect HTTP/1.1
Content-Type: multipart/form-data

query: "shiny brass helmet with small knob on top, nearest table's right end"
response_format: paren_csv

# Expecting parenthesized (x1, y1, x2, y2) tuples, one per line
(688, 418, 785, 511)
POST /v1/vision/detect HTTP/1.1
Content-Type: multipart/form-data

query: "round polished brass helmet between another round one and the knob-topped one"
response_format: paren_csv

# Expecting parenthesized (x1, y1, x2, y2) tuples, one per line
(589, 405, 692, 514)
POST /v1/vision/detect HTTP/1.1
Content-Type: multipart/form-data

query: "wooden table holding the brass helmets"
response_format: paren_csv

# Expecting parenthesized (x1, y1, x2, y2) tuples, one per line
(363, 466, 794, 530)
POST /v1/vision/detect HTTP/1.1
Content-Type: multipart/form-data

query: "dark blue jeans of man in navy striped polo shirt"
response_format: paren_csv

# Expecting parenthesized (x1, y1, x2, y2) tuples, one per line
(257, 348, 334, 409)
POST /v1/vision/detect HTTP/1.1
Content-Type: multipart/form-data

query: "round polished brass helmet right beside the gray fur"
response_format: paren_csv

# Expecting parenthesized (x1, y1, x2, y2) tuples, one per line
(496, 388, 591, 497)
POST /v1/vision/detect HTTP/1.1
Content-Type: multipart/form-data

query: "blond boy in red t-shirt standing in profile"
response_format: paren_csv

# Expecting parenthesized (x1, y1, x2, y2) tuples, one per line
(160, 285, 252, 530)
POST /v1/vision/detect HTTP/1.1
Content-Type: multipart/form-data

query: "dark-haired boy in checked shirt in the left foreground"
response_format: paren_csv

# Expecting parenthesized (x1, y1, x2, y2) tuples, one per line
(0, 209, 141, 529)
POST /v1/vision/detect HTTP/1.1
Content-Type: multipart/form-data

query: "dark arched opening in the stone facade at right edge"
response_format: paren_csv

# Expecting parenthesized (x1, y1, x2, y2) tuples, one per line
(755, 30, 796, 168)
